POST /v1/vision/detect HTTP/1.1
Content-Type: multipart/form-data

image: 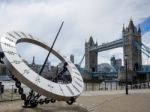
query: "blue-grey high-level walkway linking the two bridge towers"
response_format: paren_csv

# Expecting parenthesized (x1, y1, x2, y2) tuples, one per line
(90, 39, 123, 52)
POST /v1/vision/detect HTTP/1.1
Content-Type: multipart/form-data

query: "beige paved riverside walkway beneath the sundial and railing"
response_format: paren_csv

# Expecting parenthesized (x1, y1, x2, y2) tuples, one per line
(0, 89, 150, 112)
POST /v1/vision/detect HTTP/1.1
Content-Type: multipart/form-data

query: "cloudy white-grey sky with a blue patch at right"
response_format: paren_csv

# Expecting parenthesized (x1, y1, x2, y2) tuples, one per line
(0, 0, 150, 66)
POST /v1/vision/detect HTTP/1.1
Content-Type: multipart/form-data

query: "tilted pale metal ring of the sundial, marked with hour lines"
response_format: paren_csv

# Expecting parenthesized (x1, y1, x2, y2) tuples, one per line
(0, 31, 84, 101)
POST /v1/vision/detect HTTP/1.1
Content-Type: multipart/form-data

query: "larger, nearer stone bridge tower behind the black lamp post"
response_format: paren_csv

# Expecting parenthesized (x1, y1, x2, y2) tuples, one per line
(122, 19, 142, 79)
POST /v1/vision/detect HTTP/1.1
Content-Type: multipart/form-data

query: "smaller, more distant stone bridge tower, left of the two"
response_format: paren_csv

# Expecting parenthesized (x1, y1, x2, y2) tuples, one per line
(85, 36, 98, 72)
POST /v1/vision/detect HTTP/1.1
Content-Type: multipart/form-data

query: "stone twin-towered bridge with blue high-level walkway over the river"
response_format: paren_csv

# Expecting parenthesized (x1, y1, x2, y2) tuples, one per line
(85, 20, 150, 80)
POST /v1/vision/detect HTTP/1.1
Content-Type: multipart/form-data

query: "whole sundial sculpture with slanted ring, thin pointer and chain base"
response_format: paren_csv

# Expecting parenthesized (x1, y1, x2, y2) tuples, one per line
(0, 23, 84, 107)
